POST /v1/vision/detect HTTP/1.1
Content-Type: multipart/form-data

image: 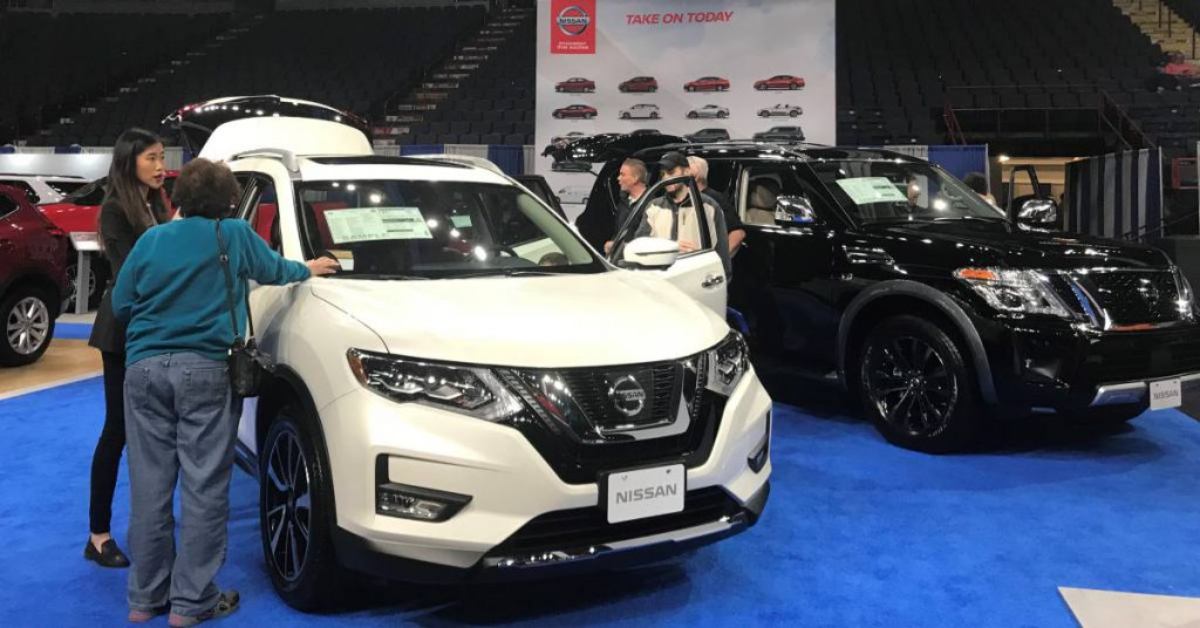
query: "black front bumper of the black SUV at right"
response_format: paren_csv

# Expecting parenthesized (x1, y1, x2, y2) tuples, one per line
(976, 319, 1200, 411)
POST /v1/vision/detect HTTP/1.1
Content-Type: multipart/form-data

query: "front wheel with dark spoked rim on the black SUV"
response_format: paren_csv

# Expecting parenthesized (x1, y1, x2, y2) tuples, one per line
(854, 316, 984, 454)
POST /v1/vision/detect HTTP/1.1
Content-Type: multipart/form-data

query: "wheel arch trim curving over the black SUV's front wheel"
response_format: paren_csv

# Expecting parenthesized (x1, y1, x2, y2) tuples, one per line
(838, 280, 998, 405)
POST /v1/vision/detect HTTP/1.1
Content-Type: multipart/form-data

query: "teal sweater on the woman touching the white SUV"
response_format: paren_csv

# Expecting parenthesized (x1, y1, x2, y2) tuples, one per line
(113, 217, 308, 365)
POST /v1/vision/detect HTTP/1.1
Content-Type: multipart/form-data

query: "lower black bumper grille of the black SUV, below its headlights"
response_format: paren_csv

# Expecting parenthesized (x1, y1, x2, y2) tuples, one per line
(1084, 331, 1200, 384)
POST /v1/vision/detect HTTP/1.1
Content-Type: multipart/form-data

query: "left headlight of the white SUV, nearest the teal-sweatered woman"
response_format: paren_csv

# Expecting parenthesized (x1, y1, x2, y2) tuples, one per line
(346, 349, 522, 420)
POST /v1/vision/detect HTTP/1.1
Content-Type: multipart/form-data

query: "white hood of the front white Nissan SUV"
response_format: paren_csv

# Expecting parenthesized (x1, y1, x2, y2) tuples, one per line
(304, 270, 728, 369)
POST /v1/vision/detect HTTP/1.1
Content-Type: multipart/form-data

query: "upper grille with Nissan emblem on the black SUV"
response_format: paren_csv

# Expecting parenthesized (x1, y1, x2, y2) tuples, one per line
(1076, 270, 1180, 325)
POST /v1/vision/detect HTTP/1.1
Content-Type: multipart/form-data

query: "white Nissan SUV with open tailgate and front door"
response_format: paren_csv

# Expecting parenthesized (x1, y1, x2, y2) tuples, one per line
(202, 118, 772, 610)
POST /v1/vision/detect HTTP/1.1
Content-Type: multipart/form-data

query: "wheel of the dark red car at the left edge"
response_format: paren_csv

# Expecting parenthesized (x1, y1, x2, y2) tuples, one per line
(0, 286, 58, 366)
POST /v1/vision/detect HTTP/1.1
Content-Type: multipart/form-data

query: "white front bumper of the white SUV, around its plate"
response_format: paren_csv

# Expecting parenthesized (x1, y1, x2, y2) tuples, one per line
(320, 370, 772, 582)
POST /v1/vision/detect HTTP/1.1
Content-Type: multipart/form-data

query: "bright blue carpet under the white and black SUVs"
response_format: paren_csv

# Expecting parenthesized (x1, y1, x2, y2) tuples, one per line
(0, 378, 1200, 627)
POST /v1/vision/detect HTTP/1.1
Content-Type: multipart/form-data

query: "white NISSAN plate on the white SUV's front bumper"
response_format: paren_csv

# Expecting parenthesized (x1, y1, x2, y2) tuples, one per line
(605, 465, 688, 524)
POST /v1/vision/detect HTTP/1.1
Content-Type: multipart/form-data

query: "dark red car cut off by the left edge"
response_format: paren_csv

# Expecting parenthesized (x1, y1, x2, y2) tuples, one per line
(0, 185, 67, 366)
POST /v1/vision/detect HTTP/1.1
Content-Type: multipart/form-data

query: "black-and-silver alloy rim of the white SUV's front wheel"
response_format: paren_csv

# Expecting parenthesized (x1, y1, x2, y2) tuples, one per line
(265, 431, 312, 582)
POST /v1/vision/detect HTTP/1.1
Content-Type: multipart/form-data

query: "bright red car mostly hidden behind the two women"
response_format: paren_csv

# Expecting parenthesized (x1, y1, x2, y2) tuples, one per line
(37, 171, 179, 312)
